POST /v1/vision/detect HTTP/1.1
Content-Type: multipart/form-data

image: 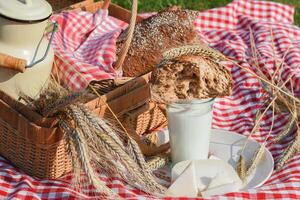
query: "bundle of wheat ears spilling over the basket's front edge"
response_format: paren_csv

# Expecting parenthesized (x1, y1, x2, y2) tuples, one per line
(24, 83, 168, 198)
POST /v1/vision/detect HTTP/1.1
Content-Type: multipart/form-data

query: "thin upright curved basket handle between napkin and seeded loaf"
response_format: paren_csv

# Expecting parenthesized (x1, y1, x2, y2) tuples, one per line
(113, 0, 138, 70)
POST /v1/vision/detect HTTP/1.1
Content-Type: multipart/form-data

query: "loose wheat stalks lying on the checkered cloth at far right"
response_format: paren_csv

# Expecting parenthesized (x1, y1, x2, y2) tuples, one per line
(246, 28, 300, 168)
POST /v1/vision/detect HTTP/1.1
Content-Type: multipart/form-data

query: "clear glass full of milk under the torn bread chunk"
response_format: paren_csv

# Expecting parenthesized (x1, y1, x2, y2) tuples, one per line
(167, 99, 214, 164)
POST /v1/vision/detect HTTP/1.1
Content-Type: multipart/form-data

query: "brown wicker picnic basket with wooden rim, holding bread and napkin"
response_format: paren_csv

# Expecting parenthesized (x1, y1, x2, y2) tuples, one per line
(0, 0, 166, 179)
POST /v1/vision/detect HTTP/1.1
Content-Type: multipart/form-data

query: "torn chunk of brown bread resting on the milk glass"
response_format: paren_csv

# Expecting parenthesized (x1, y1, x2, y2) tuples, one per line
(150, 55, 233, 103)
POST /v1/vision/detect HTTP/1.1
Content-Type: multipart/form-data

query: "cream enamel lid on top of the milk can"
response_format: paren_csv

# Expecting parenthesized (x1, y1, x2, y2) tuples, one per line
(0, 0, 52, 22)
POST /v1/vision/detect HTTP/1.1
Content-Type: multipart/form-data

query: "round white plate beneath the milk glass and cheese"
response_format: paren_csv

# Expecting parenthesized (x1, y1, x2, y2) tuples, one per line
(158, 129, 274, 190)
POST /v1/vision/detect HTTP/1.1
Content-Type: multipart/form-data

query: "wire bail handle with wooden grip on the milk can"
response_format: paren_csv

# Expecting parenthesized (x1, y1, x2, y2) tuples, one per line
(0, 23, 57, 73)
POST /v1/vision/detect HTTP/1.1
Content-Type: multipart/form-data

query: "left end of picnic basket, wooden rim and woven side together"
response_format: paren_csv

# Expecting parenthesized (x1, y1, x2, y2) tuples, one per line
(0, 100, 71, 178)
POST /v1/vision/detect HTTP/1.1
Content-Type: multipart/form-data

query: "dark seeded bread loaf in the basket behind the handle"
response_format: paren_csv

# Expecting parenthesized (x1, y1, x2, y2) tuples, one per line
(117, 7, 199, 77)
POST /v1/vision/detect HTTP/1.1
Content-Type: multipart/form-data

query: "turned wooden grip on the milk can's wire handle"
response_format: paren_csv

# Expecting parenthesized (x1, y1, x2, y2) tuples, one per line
(0, 53, 27, 73)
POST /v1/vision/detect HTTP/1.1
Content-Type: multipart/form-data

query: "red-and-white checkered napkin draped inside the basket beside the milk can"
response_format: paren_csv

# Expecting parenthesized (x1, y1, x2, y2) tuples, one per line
(51, 10, 127, 91)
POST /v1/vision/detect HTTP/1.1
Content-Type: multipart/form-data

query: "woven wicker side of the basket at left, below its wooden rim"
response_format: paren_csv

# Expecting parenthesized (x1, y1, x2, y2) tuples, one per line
(0, 119, 71, 178)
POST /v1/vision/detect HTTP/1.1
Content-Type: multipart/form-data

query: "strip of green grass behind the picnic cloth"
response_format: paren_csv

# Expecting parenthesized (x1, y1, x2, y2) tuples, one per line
(112, 0, 300, 26)
